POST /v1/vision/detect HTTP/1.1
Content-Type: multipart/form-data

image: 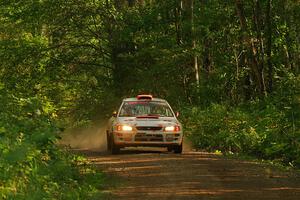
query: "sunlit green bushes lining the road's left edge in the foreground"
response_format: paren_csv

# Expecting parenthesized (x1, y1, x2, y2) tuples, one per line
(0, 89, 103, 199)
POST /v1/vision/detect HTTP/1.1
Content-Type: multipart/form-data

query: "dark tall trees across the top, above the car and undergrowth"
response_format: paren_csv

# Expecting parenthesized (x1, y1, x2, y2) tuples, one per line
(1, 0, 300, 108)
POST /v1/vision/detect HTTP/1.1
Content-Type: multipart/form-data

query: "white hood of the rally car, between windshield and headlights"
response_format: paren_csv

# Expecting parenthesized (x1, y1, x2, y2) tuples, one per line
(116, 117, 180, 126)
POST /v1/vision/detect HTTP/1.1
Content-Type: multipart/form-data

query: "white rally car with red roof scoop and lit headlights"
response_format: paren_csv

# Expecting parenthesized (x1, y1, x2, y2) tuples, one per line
(106, 95, 183, 154)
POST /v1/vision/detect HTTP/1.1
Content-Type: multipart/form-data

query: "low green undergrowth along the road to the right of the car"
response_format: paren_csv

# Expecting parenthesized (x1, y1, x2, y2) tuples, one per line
(183, 77, 300, 167)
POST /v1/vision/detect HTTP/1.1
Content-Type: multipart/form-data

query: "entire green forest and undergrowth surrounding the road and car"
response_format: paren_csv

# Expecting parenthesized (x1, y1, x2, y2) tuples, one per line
(0, 0, 300, 199)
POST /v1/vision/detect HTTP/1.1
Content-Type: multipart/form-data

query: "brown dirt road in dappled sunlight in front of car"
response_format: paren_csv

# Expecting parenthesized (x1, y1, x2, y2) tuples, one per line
(81, 148, 300, 200)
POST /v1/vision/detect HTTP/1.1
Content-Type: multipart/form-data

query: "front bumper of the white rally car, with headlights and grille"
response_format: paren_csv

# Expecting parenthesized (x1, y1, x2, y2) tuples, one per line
(113, 131, 183, 147)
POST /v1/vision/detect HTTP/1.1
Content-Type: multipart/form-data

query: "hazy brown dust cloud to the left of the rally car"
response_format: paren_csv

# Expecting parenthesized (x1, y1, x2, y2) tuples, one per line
(60, 121, 107, 151)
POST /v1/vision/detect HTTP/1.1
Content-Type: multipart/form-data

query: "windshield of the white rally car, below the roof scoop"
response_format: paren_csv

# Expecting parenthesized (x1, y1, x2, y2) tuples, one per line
(119, 101, 174, 117)
